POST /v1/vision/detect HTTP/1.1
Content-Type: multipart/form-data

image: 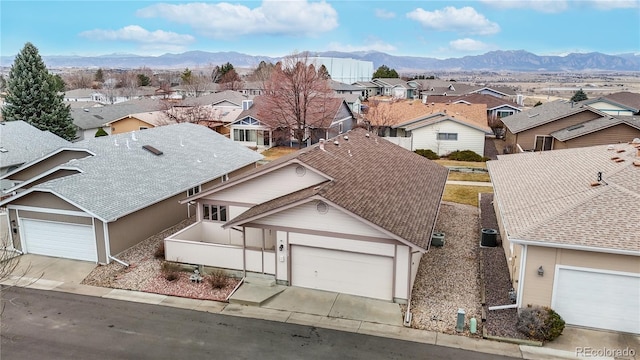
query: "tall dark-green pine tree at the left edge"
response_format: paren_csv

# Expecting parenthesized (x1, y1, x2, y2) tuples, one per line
(2, 43, 76, 140)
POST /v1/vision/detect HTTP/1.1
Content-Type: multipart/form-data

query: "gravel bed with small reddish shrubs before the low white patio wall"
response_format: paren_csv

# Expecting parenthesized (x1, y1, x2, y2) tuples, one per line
(82, 217, 239, 301)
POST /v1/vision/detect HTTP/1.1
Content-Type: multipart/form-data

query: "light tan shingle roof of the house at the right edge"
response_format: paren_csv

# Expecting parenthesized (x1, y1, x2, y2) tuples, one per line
(487, 144, 640, 256)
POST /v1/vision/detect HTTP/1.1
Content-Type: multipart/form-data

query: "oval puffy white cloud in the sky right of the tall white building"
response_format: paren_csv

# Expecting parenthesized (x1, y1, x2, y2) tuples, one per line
(407, 6, 500, 35)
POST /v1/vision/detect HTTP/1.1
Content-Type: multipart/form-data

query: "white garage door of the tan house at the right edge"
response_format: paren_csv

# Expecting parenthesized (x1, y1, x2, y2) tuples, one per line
(552, 268, 640, 333)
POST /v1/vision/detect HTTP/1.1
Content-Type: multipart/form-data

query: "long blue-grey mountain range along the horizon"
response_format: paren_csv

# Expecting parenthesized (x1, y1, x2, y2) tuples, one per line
(0, 50, 640, 72)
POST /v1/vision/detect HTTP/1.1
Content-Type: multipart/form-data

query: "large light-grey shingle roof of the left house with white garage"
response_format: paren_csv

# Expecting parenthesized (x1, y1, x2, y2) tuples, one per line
(0, 123, 262, 221)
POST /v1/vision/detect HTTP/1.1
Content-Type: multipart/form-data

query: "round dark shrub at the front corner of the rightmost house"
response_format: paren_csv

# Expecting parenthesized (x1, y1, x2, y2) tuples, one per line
(517, 305, 565, 341)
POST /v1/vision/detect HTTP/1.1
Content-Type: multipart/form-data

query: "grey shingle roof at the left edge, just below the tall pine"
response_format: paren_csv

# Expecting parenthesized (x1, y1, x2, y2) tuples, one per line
(0, 120, 71, 168)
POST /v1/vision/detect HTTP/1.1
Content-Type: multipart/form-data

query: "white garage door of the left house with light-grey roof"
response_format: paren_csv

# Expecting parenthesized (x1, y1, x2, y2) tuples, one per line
(22, 219, 98, 261)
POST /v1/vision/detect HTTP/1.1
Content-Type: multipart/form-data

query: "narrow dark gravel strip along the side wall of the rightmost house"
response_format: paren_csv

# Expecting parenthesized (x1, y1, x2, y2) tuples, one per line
(480, 193, 527, 339)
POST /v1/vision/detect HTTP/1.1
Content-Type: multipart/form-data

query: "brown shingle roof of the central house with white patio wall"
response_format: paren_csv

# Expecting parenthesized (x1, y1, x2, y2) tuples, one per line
(212, 128, 448, 249)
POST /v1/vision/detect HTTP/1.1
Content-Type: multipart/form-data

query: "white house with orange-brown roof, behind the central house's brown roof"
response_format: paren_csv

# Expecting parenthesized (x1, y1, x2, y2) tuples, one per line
(365, 100, 493, 156)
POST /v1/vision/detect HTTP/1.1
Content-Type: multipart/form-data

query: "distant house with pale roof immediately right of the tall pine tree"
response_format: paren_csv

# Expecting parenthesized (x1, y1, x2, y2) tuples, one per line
(71, 99, 161, 140)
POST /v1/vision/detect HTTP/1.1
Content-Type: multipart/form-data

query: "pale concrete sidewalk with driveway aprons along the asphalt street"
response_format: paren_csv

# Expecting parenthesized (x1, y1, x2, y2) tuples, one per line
(2, 254, 640, 360)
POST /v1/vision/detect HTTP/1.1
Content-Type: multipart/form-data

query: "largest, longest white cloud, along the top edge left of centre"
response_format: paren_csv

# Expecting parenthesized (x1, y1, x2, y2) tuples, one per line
(137, 0, 338, 39)
